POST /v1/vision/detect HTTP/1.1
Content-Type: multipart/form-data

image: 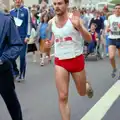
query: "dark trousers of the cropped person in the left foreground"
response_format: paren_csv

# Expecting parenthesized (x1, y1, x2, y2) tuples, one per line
(0, 63, 23, 120)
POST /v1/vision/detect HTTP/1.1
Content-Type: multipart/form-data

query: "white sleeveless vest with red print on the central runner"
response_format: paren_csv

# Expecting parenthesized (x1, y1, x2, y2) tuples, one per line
(52, 19, 84, 60)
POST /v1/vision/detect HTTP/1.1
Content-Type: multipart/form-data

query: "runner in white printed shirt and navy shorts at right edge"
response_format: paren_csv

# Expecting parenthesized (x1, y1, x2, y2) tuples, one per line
(107, 4, 120, 79)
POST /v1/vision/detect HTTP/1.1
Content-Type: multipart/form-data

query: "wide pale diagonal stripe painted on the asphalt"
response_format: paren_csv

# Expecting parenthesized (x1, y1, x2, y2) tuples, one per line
(80, 80, 120, 120)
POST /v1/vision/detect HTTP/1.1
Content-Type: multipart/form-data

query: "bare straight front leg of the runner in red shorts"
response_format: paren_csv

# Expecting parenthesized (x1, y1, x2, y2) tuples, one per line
(55, 65, 70, 120)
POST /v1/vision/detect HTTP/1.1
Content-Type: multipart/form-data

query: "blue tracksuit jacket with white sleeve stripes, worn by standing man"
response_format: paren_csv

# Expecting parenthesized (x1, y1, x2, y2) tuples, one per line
(10, 6, 31, 39)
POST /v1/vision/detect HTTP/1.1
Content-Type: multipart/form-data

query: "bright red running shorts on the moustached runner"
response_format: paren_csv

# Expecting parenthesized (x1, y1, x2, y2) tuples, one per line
(55, 55, 85, 73)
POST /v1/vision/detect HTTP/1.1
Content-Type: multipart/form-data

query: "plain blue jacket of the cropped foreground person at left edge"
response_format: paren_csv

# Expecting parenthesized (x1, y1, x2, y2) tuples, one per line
(0, 12, 23, 62)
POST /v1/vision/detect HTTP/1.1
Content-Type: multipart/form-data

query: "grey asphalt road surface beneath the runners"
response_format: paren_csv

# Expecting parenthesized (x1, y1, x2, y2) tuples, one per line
(0, 54, 120, 120)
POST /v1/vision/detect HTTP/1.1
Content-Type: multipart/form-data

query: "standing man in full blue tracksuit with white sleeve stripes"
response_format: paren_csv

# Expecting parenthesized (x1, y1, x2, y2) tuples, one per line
(10, 0, 31, 81)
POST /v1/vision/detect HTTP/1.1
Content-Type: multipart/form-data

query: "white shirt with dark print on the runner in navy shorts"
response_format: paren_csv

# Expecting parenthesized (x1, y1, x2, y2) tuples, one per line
(108, 14, 120, 39)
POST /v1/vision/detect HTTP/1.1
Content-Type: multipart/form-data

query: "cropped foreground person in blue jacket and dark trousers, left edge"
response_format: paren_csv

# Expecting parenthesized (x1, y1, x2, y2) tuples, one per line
(0, 4, 23, 120)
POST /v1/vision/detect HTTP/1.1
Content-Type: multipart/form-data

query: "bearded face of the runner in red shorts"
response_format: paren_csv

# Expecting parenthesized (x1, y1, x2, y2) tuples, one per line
(53, 0, 68, 16)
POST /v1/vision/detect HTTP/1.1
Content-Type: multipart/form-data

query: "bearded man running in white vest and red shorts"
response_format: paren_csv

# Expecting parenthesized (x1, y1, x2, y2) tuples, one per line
(46, 0, 93, 120)
